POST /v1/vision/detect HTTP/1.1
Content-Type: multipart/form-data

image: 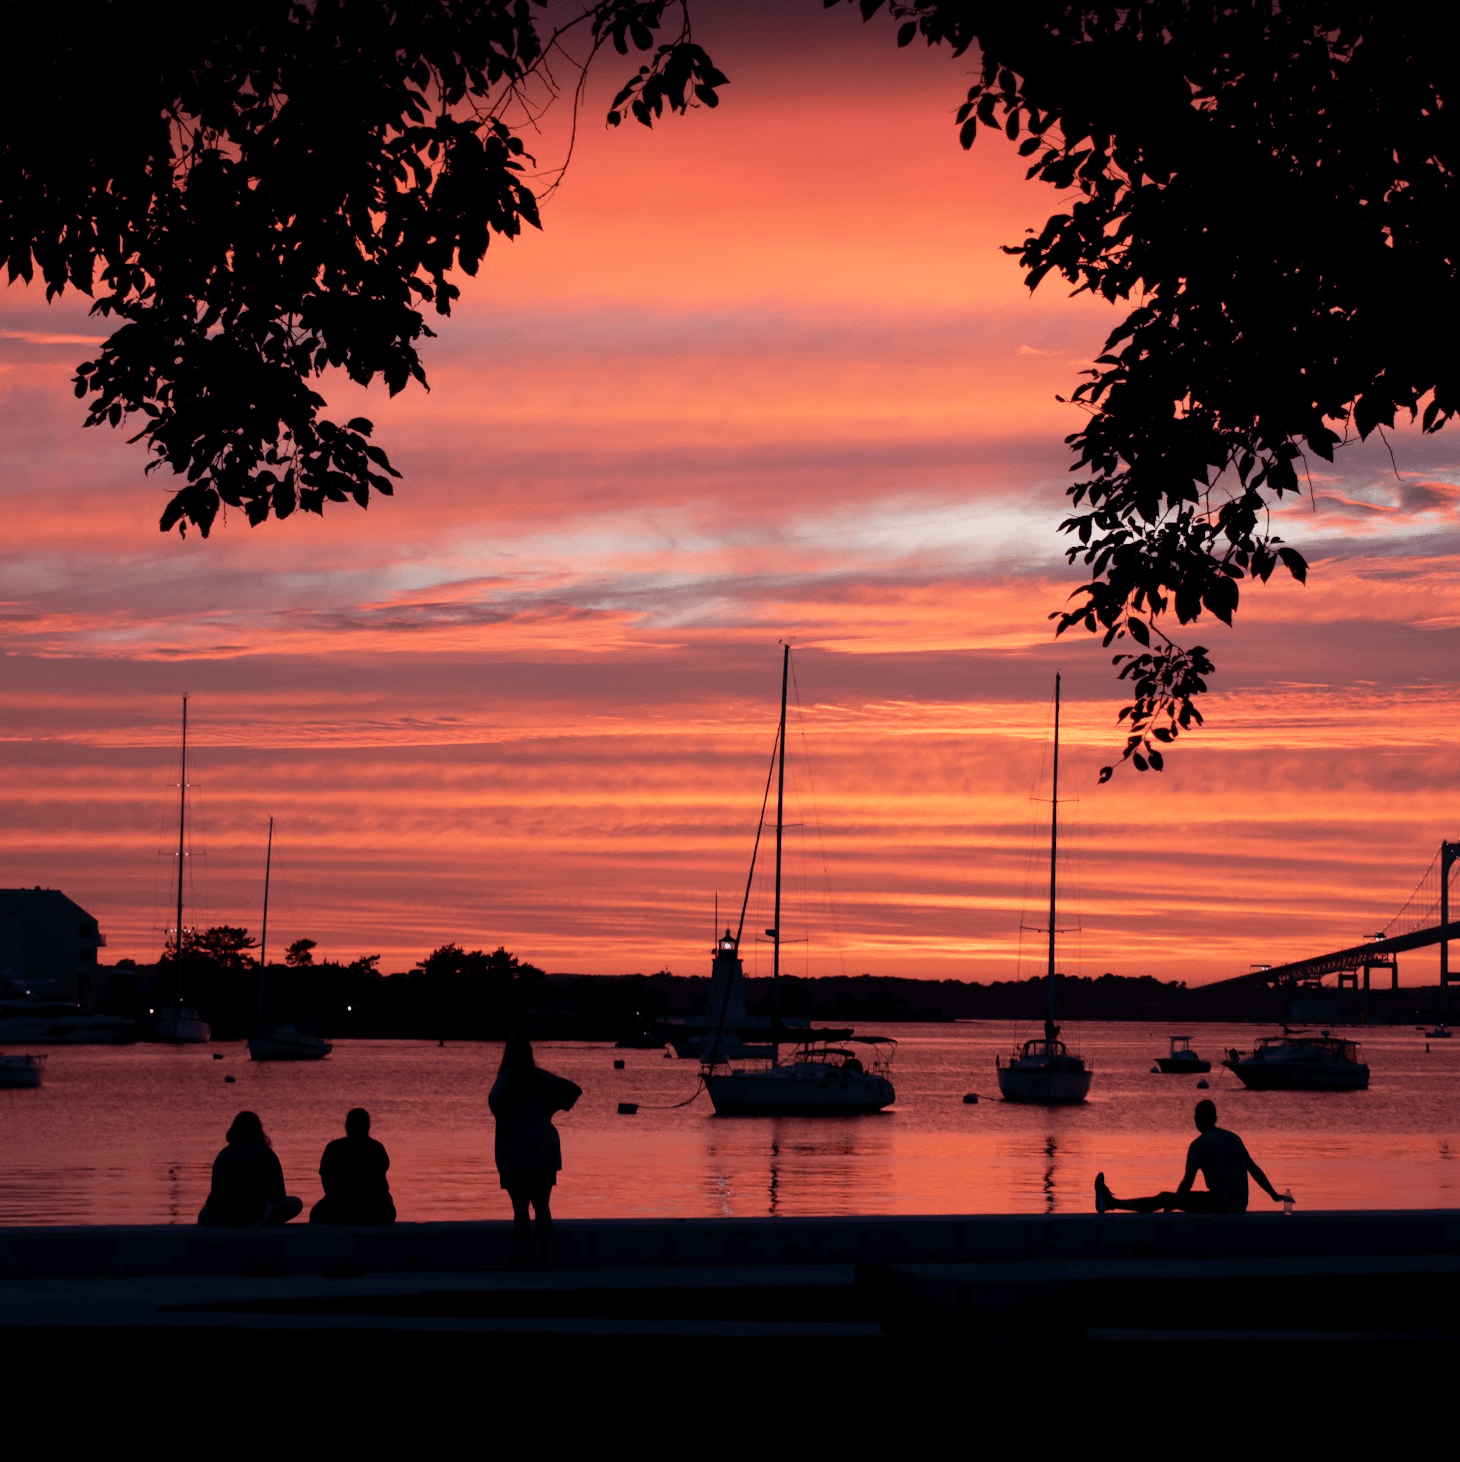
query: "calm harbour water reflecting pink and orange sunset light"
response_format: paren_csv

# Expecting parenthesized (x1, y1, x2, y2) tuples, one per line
(0, 1022, 1460, 1224)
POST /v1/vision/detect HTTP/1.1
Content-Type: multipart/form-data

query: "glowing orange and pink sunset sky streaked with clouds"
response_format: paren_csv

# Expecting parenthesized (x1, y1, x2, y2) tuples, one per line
(0, 0, 1460, 984)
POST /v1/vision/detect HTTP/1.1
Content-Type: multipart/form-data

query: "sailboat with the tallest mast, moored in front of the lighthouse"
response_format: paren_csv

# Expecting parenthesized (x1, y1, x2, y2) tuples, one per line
(700, 645, 897, 1117)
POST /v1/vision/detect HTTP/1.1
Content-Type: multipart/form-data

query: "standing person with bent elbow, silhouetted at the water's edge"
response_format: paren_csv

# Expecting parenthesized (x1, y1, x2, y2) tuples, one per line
(487, 1035, 583, 1269)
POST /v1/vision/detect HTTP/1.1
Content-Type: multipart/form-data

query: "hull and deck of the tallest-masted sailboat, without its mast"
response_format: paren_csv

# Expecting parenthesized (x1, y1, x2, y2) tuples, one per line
(704, 1035, 897, 1117)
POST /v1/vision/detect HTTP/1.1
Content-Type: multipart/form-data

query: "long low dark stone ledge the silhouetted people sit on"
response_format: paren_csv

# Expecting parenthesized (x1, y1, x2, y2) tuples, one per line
(0, 1209, 1460, 1279)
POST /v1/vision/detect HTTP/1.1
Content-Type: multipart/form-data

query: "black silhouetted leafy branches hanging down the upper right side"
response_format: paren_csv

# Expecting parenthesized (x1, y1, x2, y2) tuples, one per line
(853, 0, 1460, 781)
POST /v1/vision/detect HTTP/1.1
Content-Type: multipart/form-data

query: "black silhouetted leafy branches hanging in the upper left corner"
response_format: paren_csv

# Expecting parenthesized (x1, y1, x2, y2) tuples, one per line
(0, 0, 725, 535)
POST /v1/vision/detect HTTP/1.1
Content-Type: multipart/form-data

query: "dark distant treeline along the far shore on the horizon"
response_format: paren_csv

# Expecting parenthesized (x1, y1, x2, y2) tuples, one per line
(104, 925, 1421, 1044)
